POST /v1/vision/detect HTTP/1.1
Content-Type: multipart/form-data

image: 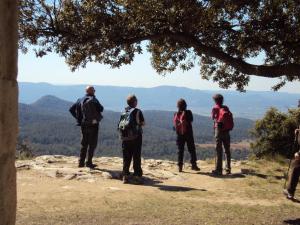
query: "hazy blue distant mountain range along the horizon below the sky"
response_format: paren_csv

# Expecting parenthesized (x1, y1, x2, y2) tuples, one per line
(19, 82, 300, 119)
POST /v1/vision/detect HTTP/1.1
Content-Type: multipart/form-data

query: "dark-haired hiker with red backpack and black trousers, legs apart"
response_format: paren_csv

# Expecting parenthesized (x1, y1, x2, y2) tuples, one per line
(173, 99, 200, 172)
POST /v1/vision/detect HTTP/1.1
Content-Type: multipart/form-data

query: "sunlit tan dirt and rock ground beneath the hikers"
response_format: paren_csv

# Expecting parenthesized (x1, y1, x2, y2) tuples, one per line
(17, 156, 300, 225)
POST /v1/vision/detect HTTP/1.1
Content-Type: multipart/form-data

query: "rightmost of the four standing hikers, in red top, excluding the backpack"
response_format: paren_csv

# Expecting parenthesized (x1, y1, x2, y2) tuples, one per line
(211, 94, 231, 176)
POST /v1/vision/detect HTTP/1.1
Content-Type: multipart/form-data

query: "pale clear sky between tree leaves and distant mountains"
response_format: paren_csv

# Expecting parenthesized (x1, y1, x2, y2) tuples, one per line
(18, 51, 300, 93)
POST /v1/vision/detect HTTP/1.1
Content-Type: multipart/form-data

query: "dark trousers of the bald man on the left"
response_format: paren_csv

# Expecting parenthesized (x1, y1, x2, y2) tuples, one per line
(79, 124, 99, 163)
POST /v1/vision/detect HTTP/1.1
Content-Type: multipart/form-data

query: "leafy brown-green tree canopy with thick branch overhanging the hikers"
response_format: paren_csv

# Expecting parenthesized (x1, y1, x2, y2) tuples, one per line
(19, 0, 300, 90)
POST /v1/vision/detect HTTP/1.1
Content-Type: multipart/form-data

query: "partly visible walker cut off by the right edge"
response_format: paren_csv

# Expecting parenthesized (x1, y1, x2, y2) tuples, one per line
(283, 100, 300, 200)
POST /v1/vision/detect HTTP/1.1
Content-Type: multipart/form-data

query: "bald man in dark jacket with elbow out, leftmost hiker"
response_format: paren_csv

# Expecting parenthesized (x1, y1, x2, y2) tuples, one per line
(69, 86, 104, 168)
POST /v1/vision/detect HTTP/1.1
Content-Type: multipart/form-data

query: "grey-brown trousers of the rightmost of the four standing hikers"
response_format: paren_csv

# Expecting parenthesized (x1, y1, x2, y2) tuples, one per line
(215, 129, 231, 171)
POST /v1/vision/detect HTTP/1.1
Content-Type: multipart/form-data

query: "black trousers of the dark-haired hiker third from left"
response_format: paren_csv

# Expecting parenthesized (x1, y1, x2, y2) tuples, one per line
(176, 134, 197, 166)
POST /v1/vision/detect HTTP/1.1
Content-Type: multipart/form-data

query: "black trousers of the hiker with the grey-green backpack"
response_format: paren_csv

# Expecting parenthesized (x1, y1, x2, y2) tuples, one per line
(122, 135, 143, 177)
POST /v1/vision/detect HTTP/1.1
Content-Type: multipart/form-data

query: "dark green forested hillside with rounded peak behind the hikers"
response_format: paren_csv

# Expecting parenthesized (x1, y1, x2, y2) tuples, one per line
(19, 96, 253, 159)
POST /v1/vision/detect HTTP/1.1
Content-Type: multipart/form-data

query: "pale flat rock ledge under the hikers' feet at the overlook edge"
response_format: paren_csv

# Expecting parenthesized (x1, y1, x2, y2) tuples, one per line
(16, 155, 184, 182)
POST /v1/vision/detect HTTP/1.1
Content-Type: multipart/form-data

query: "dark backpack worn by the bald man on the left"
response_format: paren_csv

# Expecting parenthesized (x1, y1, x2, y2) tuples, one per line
(80, 96, 102, 125)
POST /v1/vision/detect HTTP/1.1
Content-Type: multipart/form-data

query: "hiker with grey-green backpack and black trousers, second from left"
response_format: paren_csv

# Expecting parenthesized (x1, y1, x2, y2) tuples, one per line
(118, 95, 145, 184)
